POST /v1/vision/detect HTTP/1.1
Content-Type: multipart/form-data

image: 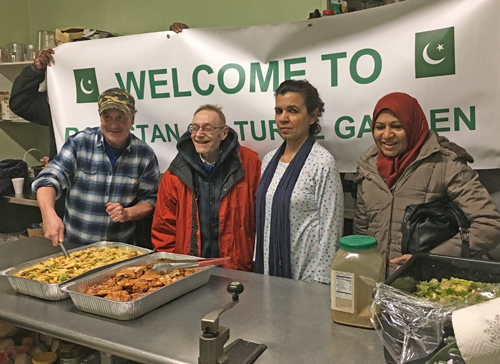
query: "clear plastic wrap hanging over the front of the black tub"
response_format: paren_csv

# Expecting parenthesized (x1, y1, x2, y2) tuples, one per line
(371, 283, 457, 364)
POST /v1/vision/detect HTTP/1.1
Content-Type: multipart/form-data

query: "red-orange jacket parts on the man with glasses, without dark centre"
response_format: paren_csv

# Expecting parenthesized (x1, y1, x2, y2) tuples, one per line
(151, 132, 261, 271)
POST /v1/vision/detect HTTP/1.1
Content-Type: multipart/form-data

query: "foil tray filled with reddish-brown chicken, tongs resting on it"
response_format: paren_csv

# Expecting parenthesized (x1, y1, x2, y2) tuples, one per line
(62, 252, 213, 320)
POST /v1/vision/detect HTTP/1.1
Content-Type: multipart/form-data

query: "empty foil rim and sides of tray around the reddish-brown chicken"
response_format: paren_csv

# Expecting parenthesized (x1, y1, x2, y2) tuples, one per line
(62, 252, 214, 320)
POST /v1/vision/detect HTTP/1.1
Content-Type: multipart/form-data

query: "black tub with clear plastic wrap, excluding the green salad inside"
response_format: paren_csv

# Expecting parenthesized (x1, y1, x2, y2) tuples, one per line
(372, 253, 500, 364)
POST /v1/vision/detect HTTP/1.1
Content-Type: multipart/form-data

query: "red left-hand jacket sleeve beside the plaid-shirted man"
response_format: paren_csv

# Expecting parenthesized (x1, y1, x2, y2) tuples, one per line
(151, 171, 178, 253)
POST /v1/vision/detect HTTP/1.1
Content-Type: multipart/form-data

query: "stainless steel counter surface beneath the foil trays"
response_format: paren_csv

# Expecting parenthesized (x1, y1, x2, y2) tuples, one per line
(0, 237, 385, 364)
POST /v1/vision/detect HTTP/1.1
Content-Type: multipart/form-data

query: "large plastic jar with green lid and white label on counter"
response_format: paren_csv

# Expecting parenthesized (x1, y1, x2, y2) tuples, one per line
(331, 235, 385, 328)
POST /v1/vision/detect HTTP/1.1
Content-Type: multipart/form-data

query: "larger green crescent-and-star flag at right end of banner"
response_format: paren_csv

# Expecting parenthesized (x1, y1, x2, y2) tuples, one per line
(415, 27, 455, 78)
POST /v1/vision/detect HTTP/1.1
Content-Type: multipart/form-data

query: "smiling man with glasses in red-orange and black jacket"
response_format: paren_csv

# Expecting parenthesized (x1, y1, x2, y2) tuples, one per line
(151, 105, 261, 271)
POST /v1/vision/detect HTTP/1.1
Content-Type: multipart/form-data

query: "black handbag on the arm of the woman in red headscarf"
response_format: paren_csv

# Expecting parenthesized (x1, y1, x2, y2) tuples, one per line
(401, 197, 470, 258)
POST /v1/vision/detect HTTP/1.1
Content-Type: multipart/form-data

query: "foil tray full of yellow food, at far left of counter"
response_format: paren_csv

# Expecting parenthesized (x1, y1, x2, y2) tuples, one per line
(0, 241, 152, 301)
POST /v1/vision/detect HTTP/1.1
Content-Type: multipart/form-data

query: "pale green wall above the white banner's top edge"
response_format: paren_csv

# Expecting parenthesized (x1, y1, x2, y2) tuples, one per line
(0, 0, 327, 47)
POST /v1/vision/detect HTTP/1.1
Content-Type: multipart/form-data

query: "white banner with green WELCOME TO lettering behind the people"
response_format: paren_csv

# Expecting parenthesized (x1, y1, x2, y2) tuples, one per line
(48, 0, 500, 172)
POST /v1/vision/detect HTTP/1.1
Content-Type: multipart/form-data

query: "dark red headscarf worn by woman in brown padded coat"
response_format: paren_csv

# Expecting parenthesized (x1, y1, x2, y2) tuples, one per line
(372, 92, 429, 188)
